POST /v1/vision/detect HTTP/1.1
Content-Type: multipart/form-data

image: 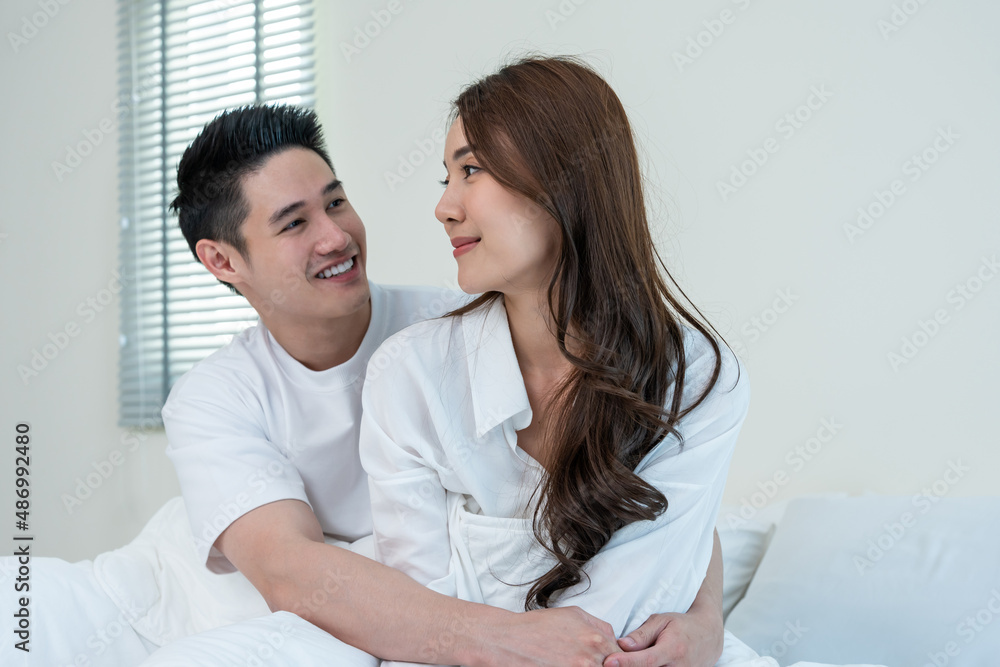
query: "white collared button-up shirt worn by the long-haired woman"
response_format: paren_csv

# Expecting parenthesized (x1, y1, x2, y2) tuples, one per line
(361, 299, 749, 636)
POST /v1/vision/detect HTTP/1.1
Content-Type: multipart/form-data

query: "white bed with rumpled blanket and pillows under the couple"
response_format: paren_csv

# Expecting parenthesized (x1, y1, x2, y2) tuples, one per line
(0, 495, 1000, 667)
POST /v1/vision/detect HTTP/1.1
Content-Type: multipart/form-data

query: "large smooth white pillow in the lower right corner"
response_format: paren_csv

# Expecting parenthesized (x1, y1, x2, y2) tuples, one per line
(726, 493, 1000, 667)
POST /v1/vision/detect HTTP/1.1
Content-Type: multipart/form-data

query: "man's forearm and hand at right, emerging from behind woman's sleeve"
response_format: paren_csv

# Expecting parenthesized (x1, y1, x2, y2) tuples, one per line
(604, 531, 723, 667)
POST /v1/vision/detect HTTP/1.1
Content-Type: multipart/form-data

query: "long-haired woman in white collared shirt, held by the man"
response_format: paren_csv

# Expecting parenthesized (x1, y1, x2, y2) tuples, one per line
(361, 58, 749, 667)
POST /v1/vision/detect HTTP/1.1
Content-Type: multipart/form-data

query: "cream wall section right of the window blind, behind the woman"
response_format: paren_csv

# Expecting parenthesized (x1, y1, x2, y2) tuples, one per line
(319, 0, 1000, 516)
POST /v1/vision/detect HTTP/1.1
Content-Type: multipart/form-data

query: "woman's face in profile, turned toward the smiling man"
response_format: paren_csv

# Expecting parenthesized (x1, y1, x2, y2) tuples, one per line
(434, 118, 559, 295)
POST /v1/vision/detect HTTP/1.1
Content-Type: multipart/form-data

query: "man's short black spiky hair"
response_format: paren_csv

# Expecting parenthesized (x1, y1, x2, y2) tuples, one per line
(170, 104, 333, 291)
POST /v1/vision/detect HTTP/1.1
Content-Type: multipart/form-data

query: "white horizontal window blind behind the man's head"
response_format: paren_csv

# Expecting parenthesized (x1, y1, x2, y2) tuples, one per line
(118, 0, 315, 427)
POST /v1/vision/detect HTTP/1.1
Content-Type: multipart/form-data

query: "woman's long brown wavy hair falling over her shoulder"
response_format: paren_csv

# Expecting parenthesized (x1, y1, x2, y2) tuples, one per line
(450, 57, 721, 609)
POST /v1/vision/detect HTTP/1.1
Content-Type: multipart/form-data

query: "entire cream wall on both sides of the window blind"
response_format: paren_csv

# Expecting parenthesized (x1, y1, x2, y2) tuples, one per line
(0, 0, 1000, 560)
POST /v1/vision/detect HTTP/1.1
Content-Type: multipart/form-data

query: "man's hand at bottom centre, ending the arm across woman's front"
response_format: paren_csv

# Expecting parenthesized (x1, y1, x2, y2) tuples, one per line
(481, 607, 619, 667)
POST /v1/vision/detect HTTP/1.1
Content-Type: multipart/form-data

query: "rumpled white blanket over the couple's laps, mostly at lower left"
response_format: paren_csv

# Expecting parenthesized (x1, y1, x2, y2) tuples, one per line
(0, 498, 888, 667)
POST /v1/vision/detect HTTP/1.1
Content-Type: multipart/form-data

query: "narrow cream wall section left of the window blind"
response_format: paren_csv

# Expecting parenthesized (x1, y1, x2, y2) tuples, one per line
(0, 0, 177, 560)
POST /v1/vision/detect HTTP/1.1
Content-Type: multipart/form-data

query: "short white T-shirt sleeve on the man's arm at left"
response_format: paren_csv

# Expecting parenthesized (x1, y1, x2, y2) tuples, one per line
(162, 368, 309, 573)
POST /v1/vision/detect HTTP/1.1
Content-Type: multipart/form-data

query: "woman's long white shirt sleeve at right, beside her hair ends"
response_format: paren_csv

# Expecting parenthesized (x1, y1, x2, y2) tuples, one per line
(557, 347, 750, 636)
